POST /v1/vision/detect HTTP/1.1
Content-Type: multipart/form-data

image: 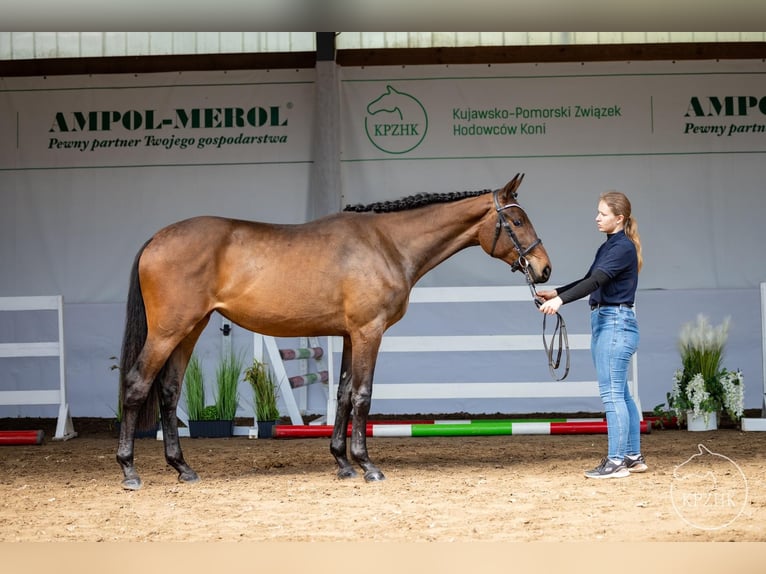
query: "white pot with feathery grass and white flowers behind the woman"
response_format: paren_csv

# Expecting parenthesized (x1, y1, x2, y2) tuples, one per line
(667, 314, 744, 430)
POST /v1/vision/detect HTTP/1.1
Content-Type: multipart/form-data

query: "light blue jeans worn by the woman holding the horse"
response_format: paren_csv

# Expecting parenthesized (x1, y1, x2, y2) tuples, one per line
(590, 307, 641, 460)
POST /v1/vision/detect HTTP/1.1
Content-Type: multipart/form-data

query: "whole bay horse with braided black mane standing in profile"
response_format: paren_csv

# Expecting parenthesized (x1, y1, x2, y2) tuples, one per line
(117, 174, 551, 490)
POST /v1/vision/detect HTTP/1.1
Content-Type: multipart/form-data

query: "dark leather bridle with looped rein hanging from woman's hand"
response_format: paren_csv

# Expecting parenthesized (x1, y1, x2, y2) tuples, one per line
(489, 189, 570, 381)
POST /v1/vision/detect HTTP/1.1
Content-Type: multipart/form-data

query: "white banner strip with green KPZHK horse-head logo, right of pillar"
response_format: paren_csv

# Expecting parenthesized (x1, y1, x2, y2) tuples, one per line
(342, 61, 766, 161)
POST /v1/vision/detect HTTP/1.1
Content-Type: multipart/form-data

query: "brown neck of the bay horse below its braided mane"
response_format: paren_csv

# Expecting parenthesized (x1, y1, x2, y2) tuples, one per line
(381, 196, 488, 284)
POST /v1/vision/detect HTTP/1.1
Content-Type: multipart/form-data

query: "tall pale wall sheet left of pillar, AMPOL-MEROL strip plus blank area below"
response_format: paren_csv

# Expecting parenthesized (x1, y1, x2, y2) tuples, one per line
(0, 70, 316, 303)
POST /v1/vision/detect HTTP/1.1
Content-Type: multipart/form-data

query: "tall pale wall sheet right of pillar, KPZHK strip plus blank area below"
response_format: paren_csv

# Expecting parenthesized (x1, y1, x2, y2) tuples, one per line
(341, 60, 766, 289)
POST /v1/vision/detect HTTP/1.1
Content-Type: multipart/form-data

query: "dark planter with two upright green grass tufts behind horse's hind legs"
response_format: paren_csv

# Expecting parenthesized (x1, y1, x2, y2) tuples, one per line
(184, 353, 242, 438)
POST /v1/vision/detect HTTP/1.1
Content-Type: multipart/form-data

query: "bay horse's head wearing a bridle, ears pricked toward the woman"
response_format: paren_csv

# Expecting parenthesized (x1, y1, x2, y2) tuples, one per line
(479, 174, 551, 283)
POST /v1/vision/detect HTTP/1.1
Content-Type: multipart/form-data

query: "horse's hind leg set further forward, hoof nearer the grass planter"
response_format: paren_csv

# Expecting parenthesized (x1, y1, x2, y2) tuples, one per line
(159, 322, 210, 482)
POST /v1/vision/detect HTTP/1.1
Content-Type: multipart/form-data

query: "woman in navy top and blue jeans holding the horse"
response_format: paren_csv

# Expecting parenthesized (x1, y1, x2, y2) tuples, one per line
(538, 191, 648, 478)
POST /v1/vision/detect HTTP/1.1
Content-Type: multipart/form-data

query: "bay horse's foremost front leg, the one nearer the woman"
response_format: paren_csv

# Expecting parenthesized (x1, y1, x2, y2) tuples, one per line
(351, 334, 386, 482)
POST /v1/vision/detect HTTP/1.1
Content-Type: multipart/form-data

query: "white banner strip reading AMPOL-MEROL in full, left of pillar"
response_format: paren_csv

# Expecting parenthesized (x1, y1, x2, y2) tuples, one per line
(0, 70, 315, 169)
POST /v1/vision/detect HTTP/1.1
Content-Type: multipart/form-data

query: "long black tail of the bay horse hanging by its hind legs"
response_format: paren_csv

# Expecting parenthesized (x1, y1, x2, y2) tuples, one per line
(119, 239, 165, 430)
